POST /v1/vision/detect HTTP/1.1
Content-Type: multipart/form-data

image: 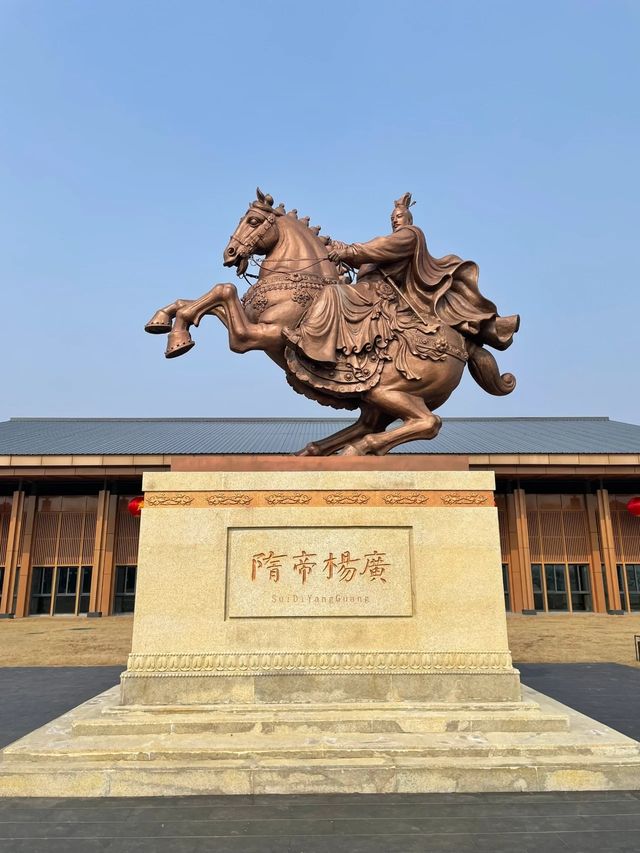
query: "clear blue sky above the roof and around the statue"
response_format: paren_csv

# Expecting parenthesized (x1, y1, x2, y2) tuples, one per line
(0, 0, 640, 423)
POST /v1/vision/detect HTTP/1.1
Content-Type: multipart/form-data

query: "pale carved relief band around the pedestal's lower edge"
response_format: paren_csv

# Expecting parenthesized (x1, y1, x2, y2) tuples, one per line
(126, 651, 512, 677)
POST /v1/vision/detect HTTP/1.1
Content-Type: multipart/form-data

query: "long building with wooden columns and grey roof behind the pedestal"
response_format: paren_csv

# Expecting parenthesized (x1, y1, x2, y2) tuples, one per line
(0, 418, 640, 618)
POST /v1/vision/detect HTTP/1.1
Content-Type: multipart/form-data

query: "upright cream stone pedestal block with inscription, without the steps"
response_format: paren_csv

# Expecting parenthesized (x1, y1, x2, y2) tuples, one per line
(122, 471, 520, 705)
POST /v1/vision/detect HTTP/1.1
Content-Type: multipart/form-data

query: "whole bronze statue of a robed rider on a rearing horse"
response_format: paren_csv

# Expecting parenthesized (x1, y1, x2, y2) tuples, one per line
(145, 189, 520, 456)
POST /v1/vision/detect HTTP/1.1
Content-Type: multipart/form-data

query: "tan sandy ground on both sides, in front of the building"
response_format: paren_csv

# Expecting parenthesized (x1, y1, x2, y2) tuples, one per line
(0, 613, 640, 666)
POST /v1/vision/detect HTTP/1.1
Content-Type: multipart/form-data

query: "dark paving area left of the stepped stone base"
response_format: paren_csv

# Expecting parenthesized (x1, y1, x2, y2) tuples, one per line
(0, 666, 124, 748)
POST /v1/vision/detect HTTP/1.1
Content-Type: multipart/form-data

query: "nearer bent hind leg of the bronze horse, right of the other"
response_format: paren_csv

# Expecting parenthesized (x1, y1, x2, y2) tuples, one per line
(342, 388, 442, 456)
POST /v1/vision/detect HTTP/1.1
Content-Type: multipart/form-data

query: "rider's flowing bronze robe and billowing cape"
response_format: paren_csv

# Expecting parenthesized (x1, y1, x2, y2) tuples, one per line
(285, 225, 520, 364)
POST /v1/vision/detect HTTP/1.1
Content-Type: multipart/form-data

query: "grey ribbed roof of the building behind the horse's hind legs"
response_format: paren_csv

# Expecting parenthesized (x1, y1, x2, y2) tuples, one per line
(0, 418, 640, 456)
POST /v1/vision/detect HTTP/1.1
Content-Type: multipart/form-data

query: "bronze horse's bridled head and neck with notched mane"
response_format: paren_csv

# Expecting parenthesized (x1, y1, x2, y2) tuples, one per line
(223, 188, 337, 278)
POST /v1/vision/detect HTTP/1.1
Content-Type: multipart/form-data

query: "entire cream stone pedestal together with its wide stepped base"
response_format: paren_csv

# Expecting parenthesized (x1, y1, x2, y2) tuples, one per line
(0, 460, 640, 796)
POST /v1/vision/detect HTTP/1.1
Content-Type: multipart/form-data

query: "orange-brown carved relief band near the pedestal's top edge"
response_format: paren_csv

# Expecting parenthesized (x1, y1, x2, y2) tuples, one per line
(145, 489, 495, 509)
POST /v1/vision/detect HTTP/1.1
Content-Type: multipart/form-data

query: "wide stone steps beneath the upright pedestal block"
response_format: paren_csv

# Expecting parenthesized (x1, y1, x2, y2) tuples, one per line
(0, 687, 640, 797)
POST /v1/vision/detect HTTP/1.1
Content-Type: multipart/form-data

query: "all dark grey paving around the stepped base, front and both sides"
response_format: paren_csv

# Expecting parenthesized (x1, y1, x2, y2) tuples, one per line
(0, 664, 640, 853)
